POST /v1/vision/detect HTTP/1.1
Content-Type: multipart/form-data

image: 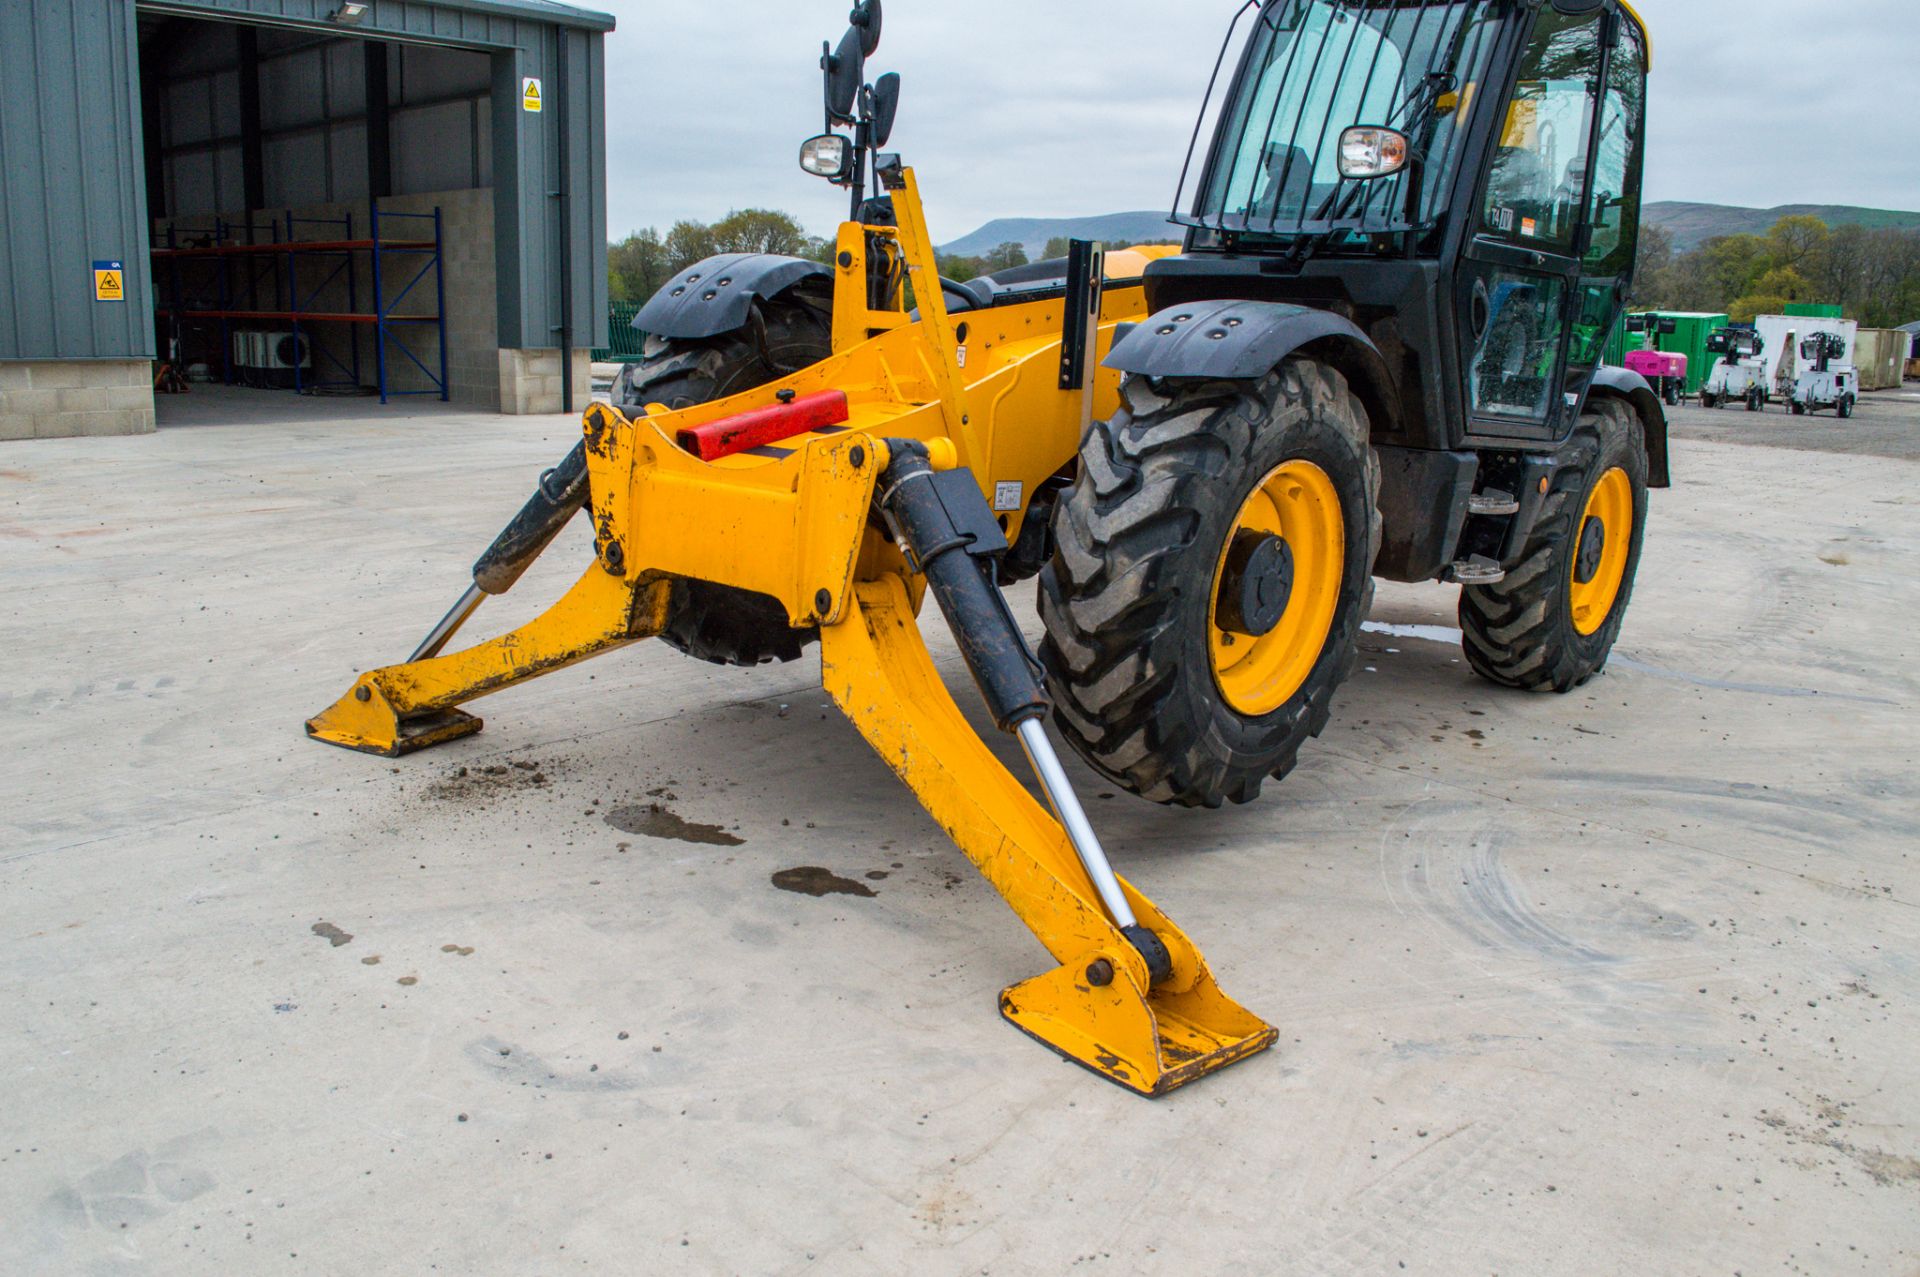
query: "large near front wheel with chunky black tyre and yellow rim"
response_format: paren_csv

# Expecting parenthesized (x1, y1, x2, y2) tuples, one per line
(1041, 357, 1380, 807)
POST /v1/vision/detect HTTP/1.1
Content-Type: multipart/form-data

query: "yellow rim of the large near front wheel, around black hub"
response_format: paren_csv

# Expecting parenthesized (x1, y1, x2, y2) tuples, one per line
(1208, 459, 1346, 716)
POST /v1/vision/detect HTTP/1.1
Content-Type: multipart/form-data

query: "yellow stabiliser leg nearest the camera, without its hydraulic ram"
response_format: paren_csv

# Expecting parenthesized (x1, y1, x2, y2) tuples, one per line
(820, 574, 1277, 1095)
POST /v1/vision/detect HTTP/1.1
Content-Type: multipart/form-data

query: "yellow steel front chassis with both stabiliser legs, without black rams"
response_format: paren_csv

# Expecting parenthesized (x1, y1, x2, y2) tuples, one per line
(307, 171, 1275, 1095)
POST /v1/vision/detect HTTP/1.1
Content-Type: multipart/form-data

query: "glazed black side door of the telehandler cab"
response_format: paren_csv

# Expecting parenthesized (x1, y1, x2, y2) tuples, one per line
(1455, 8, 1615, 440)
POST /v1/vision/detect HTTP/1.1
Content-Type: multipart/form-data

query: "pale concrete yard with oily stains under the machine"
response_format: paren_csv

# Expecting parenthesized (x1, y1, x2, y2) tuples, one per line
(0, 390, 1920, 1277)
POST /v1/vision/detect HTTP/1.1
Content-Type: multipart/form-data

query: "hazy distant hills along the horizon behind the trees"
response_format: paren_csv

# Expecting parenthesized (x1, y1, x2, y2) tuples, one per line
(941, 200, 1920, 257)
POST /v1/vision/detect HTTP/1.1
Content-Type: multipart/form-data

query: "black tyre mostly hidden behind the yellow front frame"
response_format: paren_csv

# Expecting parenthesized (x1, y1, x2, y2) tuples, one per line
(612, 300, 833, 664)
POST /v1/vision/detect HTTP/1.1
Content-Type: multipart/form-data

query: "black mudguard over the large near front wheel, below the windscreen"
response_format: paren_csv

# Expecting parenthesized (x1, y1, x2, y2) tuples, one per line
(1104, 300, 1400, 436)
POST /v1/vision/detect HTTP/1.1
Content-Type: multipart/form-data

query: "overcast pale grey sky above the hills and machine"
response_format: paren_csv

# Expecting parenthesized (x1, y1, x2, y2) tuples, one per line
(584, 0, 1920, 242)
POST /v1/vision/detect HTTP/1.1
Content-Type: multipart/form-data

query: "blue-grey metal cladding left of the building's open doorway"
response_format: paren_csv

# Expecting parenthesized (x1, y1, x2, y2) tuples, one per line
(0, 2, 154, 359)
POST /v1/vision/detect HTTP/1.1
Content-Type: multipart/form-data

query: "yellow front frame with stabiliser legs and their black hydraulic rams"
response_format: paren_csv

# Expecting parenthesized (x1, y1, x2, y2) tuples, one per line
(307, 169, 1275, 1095)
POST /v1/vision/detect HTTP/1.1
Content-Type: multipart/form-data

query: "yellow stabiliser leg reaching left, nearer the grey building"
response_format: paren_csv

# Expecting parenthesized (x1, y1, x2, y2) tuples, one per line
(307, 563, 670, 759)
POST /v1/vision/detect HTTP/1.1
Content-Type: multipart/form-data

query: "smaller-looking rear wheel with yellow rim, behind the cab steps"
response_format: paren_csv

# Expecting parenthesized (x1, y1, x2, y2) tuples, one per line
(1459, 401, 1647, 691)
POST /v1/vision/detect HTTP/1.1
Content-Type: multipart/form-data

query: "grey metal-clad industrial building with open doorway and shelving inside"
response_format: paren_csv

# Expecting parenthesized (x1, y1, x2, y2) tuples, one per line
(0, 0, 612, 440)
